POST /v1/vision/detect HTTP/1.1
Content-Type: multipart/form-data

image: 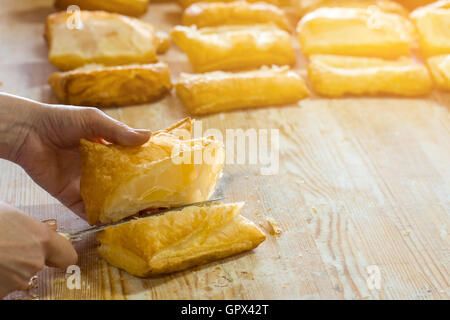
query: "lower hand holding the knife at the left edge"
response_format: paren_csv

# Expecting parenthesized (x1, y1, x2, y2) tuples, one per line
(0, 201, 78, 298)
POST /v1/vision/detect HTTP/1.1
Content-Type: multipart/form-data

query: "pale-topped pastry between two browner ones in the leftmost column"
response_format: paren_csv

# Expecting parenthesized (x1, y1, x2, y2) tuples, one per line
(46, 11, 168, 70)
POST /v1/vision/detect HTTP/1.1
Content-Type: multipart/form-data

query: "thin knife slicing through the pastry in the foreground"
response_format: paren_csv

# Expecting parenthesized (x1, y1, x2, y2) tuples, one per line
(58, 197, 224, 240)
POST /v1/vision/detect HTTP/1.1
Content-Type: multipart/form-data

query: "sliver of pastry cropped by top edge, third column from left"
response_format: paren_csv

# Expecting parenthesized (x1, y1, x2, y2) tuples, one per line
(300, 0, 409, 16)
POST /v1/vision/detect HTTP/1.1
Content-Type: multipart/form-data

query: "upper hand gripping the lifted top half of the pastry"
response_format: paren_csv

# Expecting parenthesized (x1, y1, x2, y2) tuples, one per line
(0, 93, 151, 219)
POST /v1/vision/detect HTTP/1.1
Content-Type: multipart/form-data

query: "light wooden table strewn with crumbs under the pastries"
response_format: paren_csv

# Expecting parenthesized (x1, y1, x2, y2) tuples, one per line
(0, 0, 450, 299)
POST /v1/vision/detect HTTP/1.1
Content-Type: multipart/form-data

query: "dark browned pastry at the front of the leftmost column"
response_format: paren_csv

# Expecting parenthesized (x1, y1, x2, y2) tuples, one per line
(49, 62, 172, 107)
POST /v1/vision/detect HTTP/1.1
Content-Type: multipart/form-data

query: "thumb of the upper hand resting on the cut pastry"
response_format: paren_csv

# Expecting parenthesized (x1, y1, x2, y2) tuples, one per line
(84, 109, 151, 146)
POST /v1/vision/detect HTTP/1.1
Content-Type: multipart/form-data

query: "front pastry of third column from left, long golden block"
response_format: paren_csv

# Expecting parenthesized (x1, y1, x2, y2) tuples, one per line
(308, 55, 432, 97)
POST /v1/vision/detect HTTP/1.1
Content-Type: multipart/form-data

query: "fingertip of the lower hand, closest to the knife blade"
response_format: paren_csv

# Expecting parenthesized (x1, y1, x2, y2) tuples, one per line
(45, 232, 78, 269)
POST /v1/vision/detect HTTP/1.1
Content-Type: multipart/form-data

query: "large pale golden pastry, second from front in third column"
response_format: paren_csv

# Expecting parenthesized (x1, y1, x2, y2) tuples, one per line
(297, 7, 414, 58)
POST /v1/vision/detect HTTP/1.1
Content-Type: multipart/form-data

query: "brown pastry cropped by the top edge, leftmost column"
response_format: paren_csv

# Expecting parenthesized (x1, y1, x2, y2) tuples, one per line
(55, 0, 150, 16)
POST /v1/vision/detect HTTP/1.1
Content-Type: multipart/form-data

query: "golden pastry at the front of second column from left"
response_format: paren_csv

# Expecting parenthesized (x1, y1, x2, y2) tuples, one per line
(175, 67, 309, 115)
